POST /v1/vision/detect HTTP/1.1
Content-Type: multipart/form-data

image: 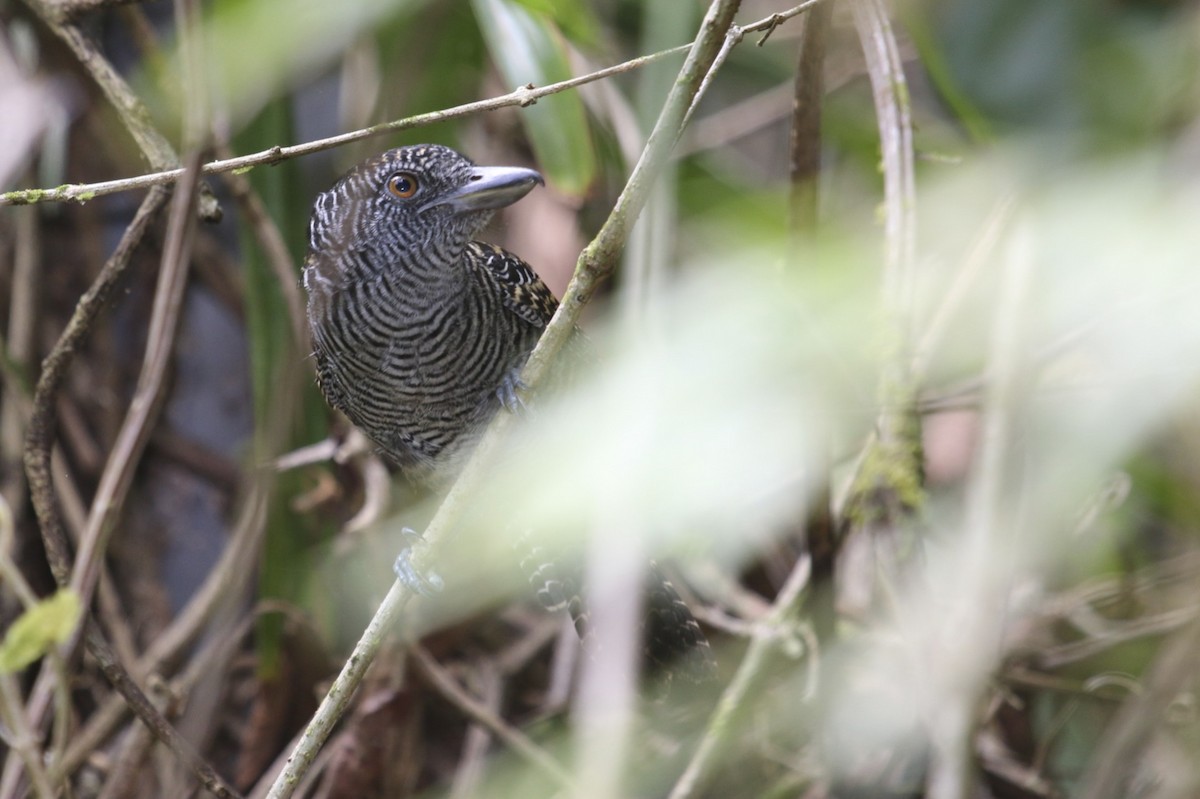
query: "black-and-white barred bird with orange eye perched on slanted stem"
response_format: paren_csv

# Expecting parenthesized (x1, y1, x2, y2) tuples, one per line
(304, 144, 712, 677)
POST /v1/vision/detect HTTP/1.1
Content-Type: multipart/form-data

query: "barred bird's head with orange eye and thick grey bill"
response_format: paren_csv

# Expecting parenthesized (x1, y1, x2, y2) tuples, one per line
(308, 144, 544, 264)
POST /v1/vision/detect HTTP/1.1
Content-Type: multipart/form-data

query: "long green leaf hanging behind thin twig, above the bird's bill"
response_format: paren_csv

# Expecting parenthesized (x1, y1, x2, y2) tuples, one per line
(472, 0, 596, 197)
